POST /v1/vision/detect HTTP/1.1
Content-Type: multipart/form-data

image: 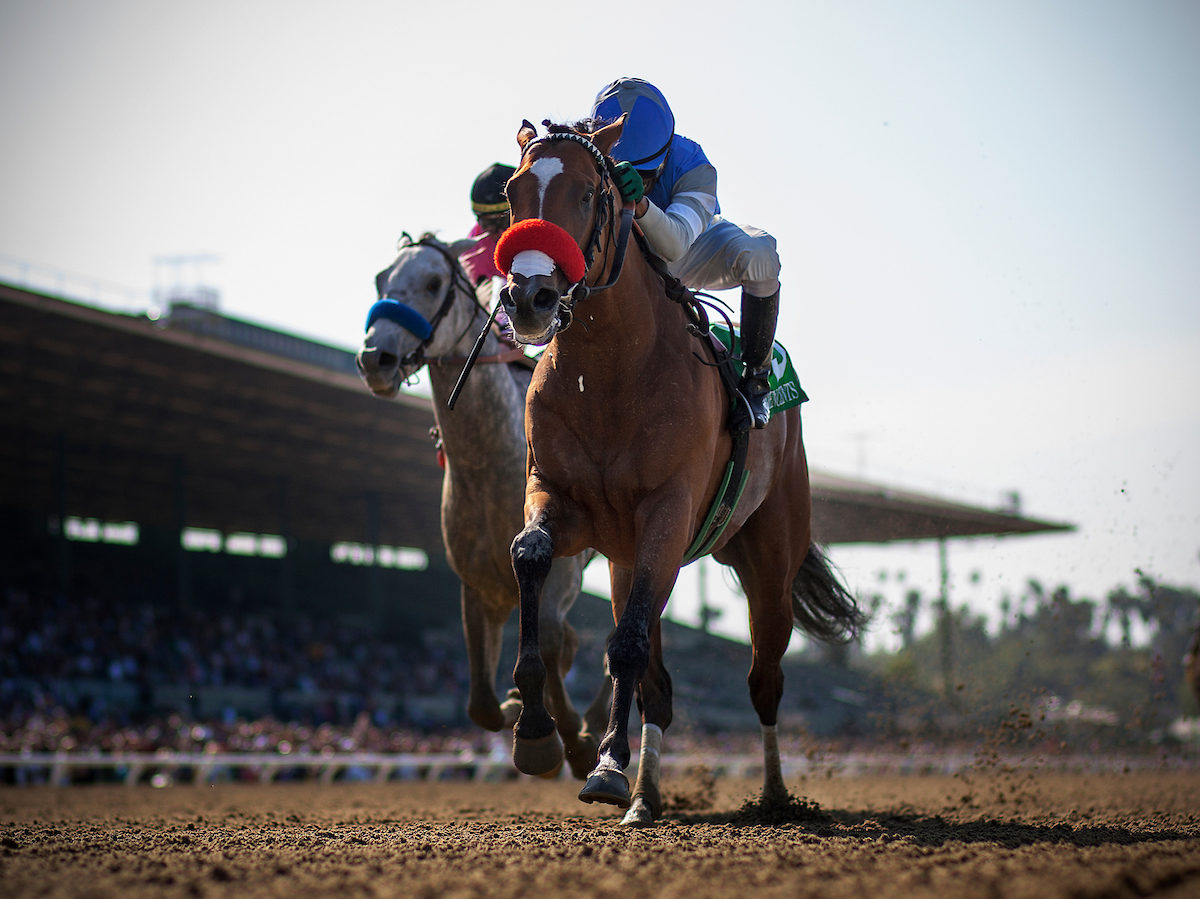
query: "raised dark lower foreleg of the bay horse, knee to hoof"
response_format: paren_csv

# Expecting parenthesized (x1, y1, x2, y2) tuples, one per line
(512, 521, 563, 775)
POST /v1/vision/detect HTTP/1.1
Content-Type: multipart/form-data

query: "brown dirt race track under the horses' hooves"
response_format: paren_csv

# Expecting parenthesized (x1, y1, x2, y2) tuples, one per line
(0, 772, 1200, 899)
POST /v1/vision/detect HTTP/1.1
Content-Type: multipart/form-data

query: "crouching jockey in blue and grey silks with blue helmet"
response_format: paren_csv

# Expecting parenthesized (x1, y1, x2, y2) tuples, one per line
(592, 78, 779, 427)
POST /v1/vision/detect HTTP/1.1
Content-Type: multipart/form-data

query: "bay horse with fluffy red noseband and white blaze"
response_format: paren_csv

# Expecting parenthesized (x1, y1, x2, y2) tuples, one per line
(496, 119, 864, 825)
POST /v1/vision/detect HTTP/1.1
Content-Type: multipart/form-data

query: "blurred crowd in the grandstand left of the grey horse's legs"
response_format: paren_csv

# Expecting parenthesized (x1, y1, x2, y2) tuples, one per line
(0, 588, 487, 753)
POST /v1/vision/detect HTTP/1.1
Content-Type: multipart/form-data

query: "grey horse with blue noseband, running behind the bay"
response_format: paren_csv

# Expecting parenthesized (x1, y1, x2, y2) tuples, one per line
(355, 234, 611, 779)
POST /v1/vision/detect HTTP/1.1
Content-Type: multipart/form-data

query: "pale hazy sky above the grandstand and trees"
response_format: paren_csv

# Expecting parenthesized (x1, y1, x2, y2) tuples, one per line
(0, 0, 1200, 646)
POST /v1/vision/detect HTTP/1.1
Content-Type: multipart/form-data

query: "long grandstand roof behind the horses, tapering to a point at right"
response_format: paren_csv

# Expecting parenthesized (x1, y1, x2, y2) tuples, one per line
(0, 283, 1069, 553)
